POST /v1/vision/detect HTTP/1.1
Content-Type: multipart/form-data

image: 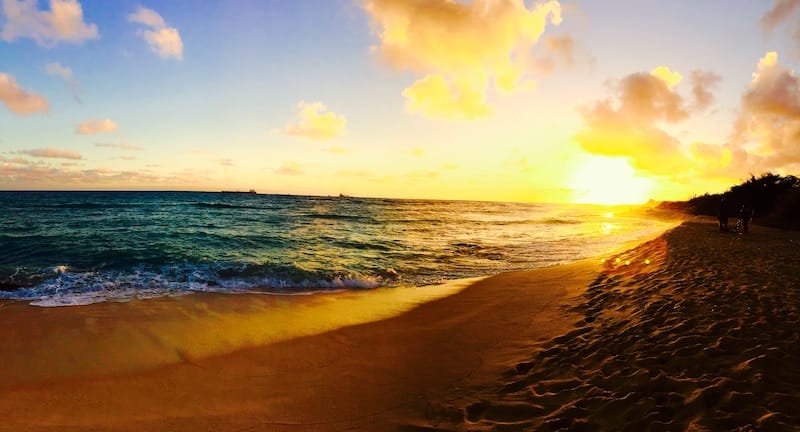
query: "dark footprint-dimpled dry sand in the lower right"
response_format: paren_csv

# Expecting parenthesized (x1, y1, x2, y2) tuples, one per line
(424, 222, 800, 431)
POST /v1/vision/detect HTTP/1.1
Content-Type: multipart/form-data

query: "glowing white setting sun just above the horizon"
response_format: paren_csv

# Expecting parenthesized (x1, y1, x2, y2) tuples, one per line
(568, 156, 654, 205)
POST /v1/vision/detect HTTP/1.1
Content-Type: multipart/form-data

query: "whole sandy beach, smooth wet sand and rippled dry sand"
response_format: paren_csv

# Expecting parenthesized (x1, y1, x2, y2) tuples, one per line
(0, 219, 800, 431)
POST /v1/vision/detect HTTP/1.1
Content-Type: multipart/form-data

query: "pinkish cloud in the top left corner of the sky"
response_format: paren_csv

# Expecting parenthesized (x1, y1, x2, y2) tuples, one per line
(0, 0, 100, 47)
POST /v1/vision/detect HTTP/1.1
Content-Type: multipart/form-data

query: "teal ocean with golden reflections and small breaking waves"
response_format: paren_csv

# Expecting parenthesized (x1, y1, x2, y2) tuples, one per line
(0, 192, 665, 306)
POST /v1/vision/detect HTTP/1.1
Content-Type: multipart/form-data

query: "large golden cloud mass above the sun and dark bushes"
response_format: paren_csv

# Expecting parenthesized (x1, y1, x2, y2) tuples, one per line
(575, 52, 800, 181)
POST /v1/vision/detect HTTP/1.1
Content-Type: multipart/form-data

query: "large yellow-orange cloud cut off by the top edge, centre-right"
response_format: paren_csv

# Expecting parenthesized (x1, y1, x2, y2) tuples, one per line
(363, 0, 561, 119)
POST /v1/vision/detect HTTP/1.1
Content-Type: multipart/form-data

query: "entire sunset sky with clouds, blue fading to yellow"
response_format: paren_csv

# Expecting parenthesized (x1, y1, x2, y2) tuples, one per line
(0, 0, 800, 204)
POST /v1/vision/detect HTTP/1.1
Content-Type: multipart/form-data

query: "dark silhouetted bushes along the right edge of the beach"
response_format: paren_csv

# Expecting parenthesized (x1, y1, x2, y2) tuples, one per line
(687, 173, 800, 229)
